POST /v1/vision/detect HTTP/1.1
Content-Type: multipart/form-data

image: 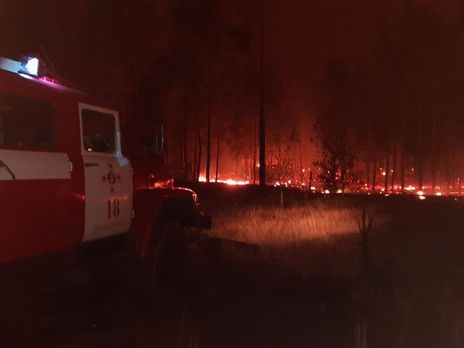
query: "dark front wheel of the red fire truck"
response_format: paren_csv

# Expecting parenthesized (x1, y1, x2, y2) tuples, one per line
(150, 221, 186, 287)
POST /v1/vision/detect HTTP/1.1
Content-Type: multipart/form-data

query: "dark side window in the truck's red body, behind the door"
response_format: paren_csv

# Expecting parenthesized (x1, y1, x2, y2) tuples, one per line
(0, 93, 57, 149)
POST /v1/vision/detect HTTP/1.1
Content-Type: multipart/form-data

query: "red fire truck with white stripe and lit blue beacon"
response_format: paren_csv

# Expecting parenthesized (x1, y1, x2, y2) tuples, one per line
(0, 58, 211, 280)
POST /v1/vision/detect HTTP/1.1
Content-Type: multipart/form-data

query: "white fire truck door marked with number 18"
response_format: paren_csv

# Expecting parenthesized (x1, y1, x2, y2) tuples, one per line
(79, 103, 132, 241)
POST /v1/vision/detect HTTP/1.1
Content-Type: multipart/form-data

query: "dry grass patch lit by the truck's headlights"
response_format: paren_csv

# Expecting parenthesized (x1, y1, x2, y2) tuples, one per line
(211, 203, 388, 276)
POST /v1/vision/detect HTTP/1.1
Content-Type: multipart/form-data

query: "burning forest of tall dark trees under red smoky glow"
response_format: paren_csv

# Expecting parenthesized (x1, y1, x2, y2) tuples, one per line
(0, 0, 464, 195)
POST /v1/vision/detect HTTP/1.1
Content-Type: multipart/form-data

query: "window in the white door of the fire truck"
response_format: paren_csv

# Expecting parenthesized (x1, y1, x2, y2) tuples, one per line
(82, 109, 116, 153)
